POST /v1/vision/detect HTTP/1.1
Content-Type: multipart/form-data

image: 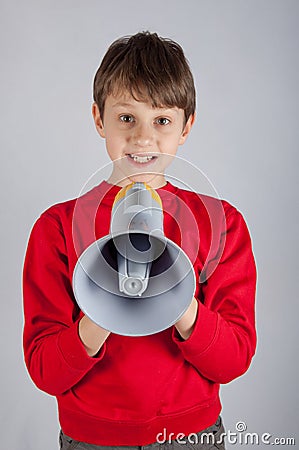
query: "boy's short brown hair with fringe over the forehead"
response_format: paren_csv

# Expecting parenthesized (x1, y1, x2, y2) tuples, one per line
(93, 31, 196, 121)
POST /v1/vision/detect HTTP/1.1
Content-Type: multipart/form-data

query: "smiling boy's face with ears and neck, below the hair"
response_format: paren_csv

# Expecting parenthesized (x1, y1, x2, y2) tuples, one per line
(92, 93, 194, 188)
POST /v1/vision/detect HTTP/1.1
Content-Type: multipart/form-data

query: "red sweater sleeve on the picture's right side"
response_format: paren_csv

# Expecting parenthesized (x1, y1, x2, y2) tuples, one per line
(173, 209, 256, 383)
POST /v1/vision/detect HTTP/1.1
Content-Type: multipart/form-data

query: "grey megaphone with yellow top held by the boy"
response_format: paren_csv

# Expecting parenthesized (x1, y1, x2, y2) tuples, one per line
(72, 182, 195, 336)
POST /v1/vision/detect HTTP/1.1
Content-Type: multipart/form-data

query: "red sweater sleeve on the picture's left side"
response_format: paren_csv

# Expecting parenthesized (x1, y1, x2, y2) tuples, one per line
(23, 213, 105, 395)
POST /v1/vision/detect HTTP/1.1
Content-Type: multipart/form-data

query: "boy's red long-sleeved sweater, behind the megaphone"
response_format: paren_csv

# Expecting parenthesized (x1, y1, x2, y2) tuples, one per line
(23, 182, 256, 445)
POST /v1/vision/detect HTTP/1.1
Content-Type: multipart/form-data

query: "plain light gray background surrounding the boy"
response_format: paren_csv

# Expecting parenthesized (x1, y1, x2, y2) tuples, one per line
(0, 0, 299, 450)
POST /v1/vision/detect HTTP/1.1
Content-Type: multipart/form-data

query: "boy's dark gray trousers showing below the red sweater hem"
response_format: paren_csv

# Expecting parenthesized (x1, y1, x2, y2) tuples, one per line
(59, 417, 225, 450)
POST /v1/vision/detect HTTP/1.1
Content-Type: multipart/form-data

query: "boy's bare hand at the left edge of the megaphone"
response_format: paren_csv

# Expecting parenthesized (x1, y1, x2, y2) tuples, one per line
(79, 316, 110, 357)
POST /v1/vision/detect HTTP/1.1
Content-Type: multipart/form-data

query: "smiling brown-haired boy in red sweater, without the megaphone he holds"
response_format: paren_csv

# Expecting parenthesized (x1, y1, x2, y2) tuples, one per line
(24, 32, 256, 450)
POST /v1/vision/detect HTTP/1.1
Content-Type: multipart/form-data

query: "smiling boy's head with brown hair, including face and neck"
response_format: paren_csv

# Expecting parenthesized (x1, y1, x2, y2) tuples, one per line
(92, 32, 195, 188)
